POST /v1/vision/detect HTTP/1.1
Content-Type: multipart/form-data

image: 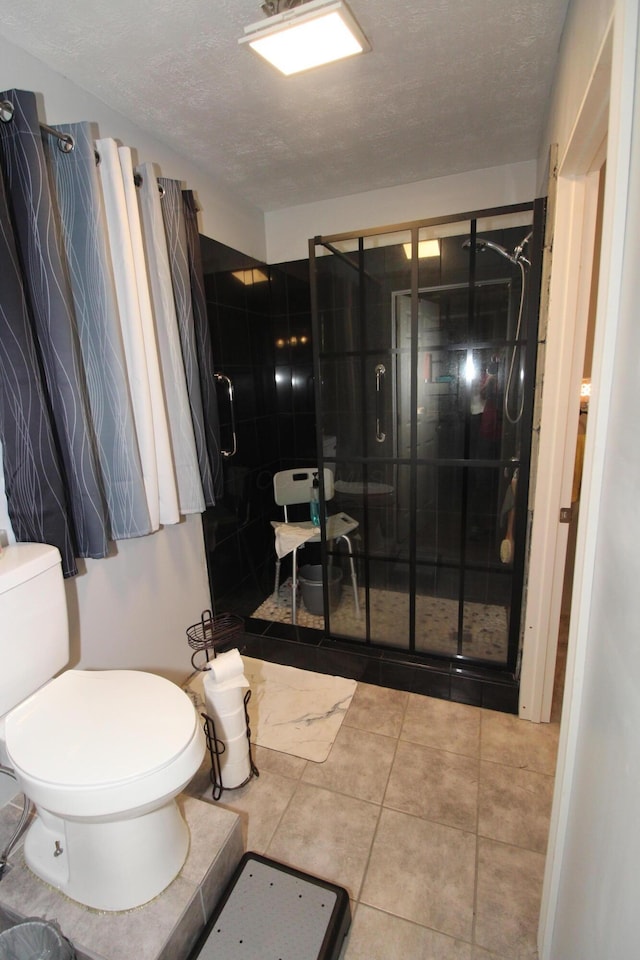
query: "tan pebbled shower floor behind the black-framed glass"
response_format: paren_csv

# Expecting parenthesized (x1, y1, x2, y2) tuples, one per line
(252, 578, 509, 662)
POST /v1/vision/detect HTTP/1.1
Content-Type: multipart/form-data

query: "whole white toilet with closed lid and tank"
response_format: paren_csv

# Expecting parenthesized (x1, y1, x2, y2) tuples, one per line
(0, 543, 205, 911)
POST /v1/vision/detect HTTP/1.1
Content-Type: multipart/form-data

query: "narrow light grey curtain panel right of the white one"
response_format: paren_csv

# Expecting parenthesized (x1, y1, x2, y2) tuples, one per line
(136, 163, 205, 514)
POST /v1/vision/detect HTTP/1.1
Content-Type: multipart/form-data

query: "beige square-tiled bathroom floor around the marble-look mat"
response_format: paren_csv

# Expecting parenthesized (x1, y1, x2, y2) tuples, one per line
(188, 682, 559, 960)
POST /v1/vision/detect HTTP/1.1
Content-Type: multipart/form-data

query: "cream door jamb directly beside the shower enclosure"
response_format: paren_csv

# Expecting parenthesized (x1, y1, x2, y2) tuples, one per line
(519, 23, 613, 723)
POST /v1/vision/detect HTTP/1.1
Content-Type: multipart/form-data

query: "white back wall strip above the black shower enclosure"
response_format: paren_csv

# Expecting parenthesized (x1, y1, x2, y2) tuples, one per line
(265, 156, 536, 263)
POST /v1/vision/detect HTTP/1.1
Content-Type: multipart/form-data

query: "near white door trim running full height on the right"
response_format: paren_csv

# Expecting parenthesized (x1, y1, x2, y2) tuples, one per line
(538, 0, 638, 960)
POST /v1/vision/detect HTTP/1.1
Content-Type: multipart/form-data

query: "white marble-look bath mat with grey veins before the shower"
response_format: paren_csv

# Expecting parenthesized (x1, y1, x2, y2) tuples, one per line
(186, 656, 356, 763)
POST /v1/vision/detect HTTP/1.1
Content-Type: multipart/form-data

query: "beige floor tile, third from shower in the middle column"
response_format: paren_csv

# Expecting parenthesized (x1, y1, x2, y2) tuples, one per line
(360, 808, 476, 942)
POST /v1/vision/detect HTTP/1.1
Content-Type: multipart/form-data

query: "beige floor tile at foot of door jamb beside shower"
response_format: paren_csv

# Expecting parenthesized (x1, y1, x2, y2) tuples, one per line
(480, 710, 560, 776)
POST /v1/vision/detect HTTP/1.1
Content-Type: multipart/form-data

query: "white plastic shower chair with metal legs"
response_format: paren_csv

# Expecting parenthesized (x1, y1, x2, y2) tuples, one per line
(273, 467, 360, 623)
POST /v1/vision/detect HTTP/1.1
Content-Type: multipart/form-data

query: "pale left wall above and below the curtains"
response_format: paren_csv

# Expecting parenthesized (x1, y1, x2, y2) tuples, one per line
(0, 37, 265, 679)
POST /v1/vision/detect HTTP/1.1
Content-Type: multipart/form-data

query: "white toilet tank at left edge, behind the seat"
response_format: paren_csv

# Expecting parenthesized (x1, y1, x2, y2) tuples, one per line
(0, 543, 69, 717)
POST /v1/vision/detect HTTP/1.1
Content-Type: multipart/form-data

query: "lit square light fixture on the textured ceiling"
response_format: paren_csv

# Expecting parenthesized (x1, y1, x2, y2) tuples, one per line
(238, 0, 371, 77)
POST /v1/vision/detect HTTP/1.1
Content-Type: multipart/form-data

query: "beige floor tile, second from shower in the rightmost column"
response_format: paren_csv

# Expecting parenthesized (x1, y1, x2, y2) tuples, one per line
(478, 761, 553, 853)
